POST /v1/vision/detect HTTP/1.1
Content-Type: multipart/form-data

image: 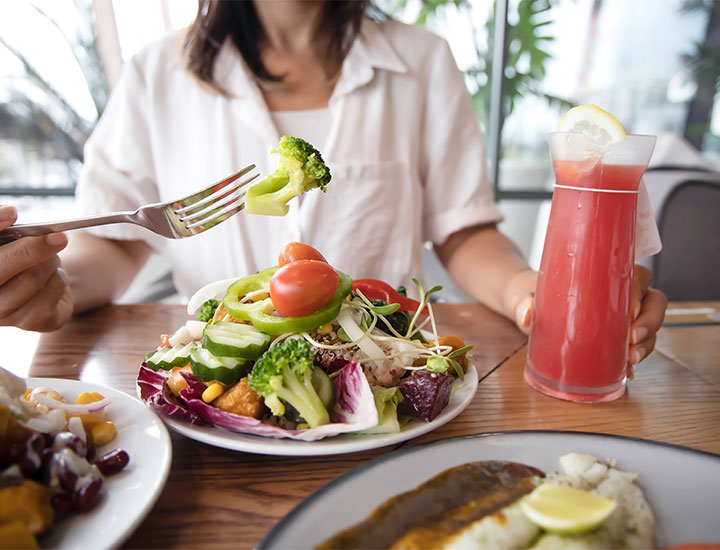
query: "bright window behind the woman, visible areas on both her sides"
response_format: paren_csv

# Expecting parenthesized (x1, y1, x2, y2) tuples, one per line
(0, 0, 720, 254)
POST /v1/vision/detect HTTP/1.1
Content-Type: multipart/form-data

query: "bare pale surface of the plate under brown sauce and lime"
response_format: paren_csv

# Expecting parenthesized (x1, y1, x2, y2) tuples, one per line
(257, 431, 720, 549)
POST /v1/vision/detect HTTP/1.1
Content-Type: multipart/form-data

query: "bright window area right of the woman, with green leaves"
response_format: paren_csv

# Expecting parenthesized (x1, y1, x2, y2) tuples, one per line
(400, 0, 720, 267)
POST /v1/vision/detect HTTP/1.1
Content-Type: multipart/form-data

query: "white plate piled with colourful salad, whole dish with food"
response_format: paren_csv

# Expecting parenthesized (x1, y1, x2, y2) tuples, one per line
(137, 242, 478, 456)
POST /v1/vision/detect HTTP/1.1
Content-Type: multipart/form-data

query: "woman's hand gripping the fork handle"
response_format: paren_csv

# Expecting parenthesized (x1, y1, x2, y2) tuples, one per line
(0, 205, 74, 332)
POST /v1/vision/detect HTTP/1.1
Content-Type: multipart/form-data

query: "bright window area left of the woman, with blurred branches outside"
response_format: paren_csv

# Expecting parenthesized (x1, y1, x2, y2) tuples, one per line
(0, 0, 197, 222)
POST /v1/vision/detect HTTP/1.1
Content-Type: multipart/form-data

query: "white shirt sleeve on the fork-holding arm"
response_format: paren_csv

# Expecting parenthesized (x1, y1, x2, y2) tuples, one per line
(75, 54, 164, 251)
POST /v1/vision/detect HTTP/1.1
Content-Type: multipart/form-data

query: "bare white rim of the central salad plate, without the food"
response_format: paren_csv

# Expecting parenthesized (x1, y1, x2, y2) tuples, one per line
(155, 367, 478, 456)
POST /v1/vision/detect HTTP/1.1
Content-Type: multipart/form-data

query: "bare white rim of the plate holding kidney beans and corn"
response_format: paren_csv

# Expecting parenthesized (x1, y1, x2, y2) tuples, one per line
(27, 378, 172, 550)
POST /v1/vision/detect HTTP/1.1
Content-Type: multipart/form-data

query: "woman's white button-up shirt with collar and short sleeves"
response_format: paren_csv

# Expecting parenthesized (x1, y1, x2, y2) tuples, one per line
(77, 19, 501, 296)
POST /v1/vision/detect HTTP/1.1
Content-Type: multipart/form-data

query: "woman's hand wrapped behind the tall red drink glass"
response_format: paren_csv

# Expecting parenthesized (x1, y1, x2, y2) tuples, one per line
(509, 265, 667, 368)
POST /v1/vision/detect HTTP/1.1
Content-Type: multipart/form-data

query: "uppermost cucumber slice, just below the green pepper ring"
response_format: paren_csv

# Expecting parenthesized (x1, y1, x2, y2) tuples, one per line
(202, 321, 271, 360)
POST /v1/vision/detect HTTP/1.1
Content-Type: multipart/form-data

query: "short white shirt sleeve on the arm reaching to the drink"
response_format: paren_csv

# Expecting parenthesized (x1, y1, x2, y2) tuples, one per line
(421, 40, 502, 244)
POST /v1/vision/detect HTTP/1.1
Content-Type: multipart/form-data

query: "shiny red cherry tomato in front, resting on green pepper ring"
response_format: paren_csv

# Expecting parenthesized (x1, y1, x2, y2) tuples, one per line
(270, 260, 338, 317)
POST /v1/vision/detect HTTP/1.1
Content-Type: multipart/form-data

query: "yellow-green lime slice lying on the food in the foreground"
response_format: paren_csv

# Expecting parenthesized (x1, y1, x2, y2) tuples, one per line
(520, 483, 617, 534)
